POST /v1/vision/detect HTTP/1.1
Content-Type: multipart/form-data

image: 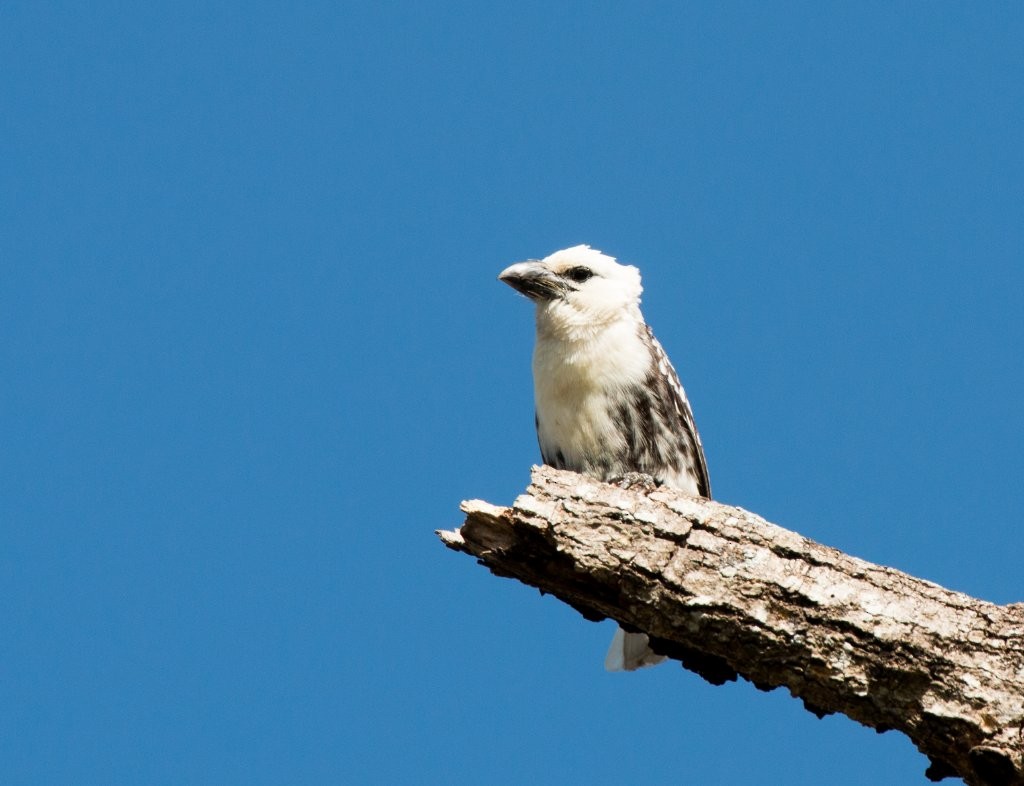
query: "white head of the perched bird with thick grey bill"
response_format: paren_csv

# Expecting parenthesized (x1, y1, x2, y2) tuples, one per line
(498, 246, 643, 330)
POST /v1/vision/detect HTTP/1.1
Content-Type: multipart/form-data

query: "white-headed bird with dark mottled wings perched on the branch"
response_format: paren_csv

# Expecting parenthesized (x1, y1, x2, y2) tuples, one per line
(498, 246, 711, 671)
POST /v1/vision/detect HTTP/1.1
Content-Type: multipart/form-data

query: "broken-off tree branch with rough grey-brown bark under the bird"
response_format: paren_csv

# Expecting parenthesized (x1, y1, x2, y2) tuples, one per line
(438, 467, 1024, 786)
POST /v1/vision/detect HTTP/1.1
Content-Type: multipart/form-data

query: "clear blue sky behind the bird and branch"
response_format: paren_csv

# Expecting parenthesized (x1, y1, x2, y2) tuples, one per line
(0, 1, 1024, 784)
